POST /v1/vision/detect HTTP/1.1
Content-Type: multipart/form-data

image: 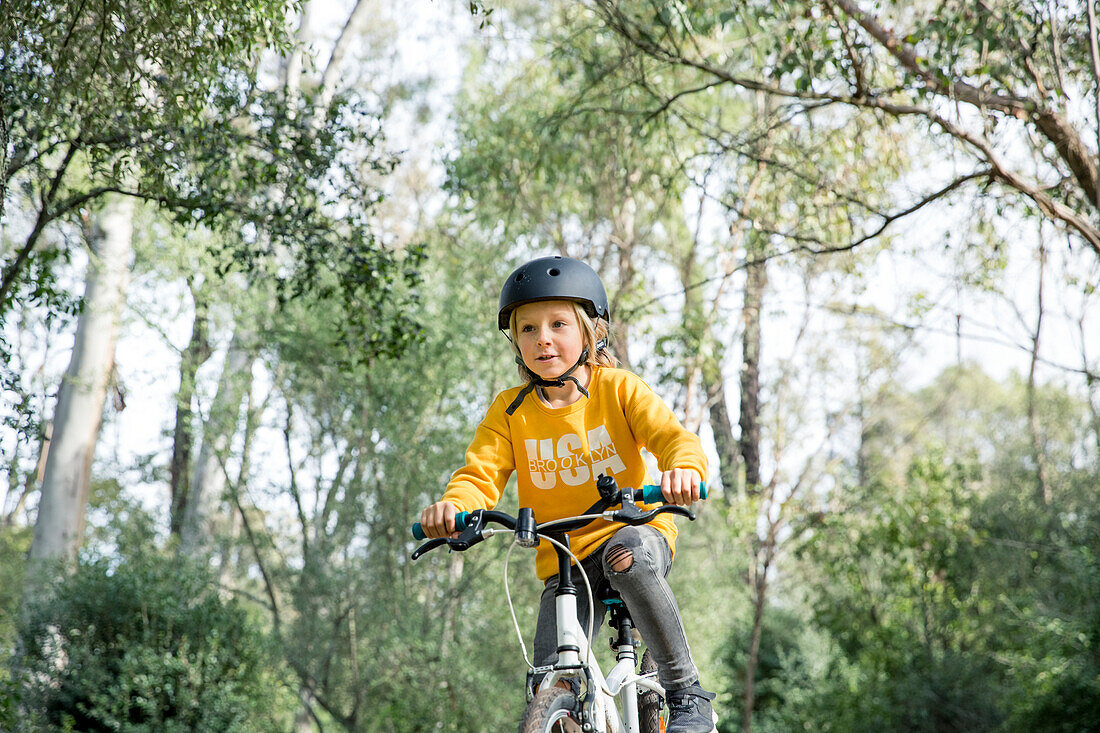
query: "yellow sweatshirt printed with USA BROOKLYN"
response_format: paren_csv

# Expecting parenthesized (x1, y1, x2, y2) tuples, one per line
(443, 367, 706, 580)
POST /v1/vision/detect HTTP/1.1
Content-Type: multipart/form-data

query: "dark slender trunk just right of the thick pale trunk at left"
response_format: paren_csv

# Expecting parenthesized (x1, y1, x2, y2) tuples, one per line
(168, 280, 211, 537)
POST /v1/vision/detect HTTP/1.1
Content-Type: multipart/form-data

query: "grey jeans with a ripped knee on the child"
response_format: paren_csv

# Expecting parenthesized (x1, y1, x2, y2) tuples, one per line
(535, 525, 699, 690)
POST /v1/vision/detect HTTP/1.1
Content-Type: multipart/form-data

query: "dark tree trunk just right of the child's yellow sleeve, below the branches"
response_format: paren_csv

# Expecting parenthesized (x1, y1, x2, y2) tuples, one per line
(738, 247, 768, 494)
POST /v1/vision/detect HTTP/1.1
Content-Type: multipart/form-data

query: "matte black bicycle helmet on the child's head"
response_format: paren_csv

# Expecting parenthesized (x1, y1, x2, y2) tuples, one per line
(496, 254, 611, 331)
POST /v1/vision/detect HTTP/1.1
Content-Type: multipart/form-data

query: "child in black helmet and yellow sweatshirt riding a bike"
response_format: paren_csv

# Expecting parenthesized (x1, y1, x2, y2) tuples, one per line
(420, 256, 714, 733)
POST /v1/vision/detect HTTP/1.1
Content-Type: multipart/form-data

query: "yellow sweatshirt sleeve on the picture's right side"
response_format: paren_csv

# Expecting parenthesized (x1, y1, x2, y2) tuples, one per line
(624, 376, 707, 481)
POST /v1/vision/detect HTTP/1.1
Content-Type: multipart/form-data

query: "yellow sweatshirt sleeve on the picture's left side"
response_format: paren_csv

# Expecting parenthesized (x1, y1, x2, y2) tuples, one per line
(442, 395, 516, 512)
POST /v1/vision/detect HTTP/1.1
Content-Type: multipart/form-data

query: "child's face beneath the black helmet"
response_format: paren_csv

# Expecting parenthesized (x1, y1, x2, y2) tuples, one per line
(516, 300, 584, 380)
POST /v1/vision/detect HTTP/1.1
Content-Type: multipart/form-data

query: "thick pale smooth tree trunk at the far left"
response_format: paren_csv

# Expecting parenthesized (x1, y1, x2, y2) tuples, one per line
(30, 196, 134, 560)
